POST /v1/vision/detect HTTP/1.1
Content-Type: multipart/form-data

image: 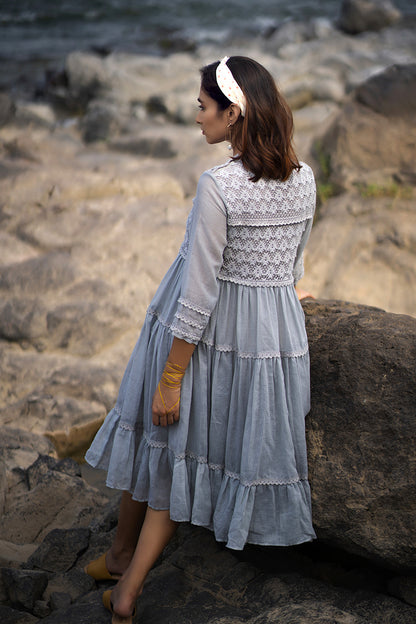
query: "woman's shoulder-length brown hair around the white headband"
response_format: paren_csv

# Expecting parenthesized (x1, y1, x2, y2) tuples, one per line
(201, 56, 300, 182)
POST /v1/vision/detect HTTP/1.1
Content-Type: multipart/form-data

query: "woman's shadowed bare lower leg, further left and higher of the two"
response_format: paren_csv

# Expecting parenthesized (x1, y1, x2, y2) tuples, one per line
(106, 492, 147, 574)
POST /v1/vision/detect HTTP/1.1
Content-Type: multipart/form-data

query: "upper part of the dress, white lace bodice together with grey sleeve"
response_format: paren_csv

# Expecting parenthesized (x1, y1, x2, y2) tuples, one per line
(172, 160, 316, 342)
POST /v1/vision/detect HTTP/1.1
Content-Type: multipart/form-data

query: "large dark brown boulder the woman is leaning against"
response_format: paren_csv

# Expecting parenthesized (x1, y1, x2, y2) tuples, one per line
(303, 301, 416, 573)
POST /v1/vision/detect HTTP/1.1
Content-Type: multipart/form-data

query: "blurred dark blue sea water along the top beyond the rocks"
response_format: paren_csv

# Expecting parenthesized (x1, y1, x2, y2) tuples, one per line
(0, 0, 415, 94)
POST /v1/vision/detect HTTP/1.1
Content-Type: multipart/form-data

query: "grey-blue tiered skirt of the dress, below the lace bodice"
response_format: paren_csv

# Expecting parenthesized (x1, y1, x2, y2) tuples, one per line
(86, 255, 315, 550)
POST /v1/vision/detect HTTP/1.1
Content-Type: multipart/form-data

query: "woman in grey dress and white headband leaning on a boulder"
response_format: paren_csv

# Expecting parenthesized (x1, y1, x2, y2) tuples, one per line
(86, 56, 315, 622)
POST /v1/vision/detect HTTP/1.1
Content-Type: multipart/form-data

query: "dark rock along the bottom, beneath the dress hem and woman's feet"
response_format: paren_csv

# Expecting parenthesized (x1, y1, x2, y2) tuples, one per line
(39, 526, 416, 624)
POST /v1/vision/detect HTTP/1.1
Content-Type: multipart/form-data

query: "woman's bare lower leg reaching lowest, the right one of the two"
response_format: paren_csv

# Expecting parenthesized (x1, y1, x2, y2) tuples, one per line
(111, 507, 178, 622)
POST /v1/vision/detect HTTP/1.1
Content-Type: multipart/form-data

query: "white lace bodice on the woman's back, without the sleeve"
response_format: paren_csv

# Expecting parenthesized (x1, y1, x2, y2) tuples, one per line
(181, 161, 315, 286)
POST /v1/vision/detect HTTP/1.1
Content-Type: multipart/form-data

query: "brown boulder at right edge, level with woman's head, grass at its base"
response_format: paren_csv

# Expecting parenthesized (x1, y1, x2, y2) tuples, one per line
(321, 64, 416, 188)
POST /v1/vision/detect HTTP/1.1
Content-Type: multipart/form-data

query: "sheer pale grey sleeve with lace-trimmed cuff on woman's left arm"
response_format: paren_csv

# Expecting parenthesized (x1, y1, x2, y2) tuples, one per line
(172, 173, 227, 344)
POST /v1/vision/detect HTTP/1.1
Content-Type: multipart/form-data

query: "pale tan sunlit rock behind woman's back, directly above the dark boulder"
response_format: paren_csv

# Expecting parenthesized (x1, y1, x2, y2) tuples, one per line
(302, 190, 416, 316)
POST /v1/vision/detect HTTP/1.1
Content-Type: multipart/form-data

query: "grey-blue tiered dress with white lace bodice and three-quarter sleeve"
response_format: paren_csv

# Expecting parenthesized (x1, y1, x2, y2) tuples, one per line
(86, 160, 315, 550)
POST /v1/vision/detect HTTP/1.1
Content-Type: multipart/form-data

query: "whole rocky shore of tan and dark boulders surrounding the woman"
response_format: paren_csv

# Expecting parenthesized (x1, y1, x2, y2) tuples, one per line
(0, 1, 416, 624)
